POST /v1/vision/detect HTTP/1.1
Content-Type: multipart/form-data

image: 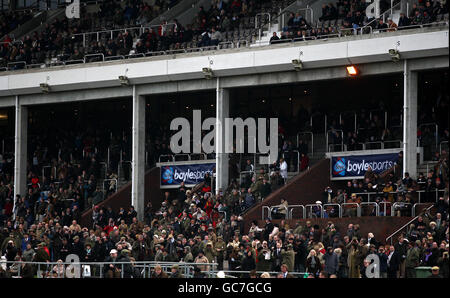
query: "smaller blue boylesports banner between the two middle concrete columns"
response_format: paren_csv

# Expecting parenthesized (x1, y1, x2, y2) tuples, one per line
(161, 163, 216, 187)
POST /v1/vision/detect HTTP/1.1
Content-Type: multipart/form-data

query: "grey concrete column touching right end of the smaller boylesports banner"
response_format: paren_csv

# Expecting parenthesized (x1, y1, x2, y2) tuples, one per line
(215, 78, 230, 193)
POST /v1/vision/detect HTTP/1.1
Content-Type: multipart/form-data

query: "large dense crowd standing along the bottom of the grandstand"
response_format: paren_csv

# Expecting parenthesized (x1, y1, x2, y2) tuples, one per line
(0, 173, 449, 278)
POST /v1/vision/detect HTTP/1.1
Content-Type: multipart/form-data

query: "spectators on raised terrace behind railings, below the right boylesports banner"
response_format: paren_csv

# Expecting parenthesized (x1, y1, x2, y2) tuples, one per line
(317, 151, 449, 218)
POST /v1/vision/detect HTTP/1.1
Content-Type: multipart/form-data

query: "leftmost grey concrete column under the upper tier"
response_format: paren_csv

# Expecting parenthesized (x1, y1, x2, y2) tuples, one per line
(14, 96, 28, 218)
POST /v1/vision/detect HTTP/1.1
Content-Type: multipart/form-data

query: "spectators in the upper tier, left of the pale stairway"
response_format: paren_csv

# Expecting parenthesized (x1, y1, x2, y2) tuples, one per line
(0, 0, 284, 67)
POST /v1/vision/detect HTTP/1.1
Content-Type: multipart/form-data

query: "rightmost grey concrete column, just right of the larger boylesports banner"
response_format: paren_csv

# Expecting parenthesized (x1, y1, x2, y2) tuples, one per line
(403, 60, 418, 179)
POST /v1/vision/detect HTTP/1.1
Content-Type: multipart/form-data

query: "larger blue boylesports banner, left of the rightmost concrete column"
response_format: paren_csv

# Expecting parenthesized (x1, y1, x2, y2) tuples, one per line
(331, 153, 398, 178)
